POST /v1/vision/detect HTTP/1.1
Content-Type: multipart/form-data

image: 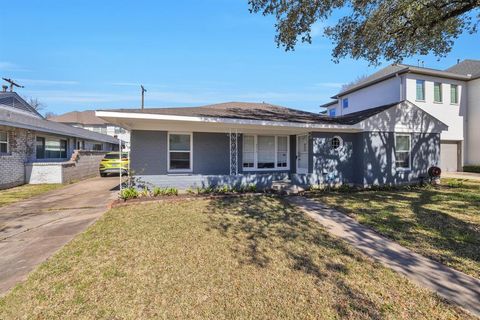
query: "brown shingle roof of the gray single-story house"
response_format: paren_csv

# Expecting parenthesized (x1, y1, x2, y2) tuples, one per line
(98, 102, 400, 125)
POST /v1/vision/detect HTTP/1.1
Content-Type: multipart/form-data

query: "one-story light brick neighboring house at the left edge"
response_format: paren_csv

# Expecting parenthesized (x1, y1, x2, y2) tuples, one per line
(0, 92, 118, 189)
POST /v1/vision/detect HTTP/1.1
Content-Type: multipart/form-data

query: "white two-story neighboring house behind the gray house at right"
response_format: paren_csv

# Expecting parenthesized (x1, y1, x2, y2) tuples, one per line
(321, 60, 480, 171)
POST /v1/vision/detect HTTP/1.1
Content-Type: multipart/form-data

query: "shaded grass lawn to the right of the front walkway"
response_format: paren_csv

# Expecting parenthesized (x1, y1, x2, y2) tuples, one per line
(311, 179, 480, 279)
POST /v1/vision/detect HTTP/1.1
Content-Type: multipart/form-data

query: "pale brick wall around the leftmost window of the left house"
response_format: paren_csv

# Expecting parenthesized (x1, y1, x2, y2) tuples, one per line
(0, 126, 35, 189)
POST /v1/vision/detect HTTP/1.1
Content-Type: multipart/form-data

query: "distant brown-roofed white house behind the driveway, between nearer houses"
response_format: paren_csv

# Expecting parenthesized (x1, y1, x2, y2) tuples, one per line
(48, 110, 130, 151)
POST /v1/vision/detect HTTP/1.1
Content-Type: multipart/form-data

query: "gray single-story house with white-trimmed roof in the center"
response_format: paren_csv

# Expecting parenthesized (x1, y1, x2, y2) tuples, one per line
(96, 101, 447, 188)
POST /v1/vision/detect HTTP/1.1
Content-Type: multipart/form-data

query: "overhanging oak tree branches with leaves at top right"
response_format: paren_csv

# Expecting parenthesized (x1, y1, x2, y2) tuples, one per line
(248, 0, 480, 64)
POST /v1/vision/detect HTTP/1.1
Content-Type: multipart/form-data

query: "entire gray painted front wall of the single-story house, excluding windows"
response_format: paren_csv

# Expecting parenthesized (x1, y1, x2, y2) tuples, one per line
(131, 131, 440, 188)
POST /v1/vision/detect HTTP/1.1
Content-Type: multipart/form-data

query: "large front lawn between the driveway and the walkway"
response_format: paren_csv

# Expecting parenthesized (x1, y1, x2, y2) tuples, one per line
(0, 196, 471, 319)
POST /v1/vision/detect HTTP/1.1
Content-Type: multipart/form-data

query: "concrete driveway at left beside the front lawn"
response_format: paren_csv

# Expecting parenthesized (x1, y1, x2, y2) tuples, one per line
(0, 177, 119, 295)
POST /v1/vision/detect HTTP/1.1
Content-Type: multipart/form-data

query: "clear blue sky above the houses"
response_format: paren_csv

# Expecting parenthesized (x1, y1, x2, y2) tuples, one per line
(0, 0, 480, 113)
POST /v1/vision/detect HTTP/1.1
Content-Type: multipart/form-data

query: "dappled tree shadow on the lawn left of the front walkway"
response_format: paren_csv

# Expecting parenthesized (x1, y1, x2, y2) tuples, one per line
(207, 197, 383, 319)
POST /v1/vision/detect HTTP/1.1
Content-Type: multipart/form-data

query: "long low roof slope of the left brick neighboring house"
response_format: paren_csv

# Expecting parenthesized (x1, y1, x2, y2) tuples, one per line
(0, 107, 118, 144)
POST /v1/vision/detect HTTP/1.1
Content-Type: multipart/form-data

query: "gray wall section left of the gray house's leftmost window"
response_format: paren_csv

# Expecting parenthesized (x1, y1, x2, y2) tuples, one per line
(130, 130, 167, 175)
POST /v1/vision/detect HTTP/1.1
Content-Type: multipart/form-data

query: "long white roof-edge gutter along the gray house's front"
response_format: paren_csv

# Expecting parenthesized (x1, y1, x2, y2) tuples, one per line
(95, 111, 360, 131)
